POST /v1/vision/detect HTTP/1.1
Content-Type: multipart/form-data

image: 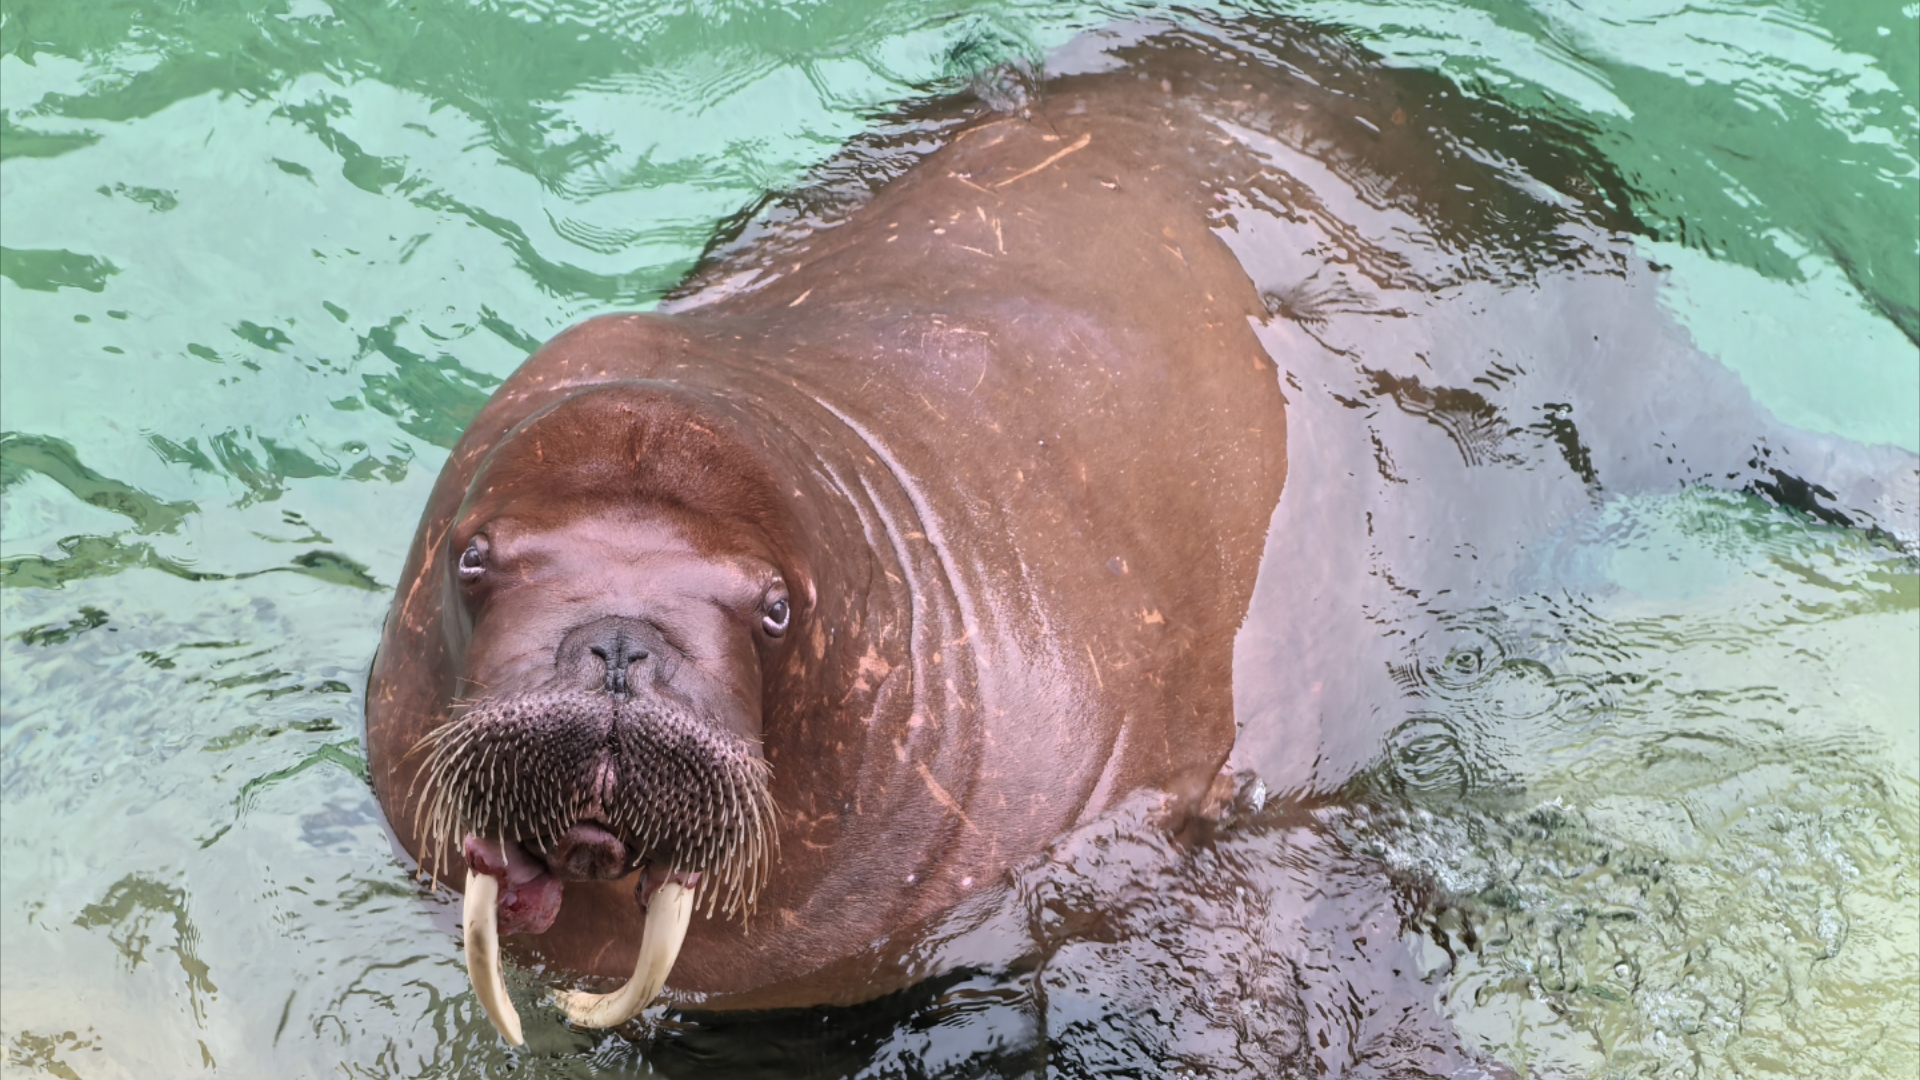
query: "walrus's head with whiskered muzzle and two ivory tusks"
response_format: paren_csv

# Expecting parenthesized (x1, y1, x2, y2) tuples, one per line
(420, 382, 808, 1042)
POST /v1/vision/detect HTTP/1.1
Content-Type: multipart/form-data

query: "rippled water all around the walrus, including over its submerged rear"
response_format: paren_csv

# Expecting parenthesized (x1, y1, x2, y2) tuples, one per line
(0, 0, 1920, 1080)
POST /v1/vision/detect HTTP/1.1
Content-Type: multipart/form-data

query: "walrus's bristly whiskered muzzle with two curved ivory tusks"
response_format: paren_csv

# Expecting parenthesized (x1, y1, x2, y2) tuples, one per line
(422, 692, 774, 1045)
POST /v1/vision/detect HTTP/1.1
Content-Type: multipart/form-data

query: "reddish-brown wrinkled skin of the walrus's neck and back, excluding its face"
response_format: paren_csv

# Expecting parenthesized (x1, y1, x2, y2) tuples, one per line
(369, 58, 1286, 1007)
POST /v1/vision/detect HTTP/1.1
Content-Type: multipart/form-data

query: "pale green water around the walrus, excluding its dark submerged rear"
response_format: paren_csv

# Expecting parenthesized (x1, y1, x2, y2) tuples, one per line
(0, 0, 1920, 1080)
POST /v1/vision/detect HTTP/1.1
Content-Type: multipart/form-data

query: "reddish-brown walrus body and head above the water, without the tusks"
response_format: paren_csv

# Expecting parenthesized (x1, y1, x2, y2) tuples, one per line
(369, 46, 1286, 1007)
